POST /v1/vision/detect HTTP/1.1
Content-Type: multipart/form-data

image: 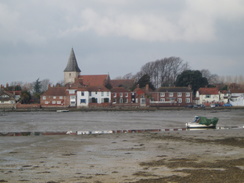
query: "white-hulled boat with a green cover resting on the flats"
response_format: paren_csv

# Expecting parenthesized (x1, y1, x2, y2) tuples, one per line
(186, 116, 219, 128)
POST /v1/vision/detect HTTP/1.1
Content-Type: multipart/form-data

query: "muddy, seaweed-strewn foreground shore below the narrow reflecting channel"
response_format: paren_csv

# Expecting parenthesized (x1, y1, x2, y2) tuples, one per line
(0, 129, 244, 183)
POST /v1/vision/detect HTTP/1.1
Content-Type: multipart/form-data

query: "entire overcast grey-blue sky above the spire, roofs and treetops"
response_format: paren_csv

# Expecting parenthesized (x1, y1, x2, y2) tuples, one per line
(0, 0, 244, 85)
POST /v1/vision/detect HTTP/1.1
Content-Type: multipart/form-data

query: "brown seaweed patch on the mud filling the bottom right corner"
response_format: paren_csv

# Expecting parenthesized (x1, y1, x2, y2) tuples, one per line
(135, 158, 244, 183)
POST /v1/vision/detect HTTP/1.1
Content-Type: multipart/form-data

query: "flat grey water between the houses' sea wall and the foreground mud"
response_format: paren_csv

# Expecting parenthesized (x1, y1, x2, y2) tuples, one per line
(0, 110, 244, 132)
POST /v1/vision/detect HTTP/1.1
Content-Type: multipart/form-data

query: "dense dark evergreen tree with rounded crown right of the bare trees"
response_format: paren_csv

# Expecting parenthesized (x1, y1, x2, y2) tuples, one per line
(175, 70, 208, 95)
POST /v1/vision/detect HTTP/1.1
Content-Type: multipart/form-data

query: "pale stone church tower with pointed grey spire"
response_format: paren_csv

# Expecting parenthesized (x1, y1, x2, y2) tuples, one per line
(64, 48, 81, 84)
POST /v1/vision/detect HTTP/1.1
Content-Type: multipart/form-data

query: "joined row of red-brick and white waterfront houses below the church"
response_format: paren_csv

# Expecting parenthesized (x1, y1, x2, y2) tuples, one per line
(40, 83, 193, 108)
